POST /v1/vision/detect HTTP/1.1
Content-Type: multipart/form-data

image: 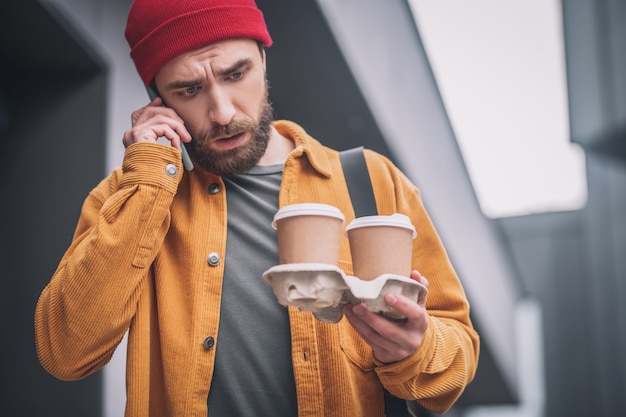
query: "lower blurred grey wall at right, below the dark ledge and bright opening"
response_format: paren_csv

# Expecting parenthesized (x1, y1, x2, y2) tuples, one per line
(498, 154, 626, 417)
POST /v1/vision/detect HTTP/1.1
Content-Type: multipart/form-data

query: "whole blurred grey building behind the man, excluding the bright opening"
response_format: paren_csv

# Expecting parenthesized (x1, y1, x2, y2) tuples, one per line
(0, 0, 626, 417)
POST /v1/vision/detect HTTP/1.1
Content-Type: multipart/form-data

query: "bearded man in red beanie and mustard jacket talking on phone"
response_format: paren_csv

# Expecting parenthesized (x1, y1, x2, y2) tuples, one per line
(35, 0, 479, 417)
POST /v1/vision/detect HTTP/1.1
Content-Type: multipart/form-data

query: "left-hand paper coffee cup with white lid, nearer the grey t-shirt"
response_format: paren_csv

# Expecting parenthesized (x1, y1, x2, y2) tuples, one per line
(272, 203, 345, 265)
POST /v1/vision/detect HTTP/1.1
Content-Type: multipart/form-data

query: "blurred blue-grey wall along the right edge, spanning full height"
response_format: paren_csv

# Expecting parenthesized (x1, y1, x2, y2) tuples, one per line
(499, 0, 626, 417)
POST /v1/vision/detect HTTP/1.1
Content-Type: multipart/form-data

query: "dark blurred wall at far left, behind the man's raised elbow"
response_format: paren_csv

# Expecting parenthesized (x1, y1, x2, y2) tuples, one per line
(0, 0, 107, 417)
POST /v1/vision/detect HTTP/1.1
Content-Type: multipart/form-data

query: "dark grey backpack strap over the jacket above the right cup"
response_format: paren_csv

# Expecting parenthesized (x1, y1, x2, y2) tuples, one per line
(339, 146, 378, 217)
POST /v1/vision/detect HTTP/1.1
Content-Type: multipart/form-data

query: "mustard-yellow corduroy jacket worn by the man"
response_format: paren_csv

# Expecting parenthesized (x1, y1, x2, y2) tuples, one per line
(35, 121, 479, 417)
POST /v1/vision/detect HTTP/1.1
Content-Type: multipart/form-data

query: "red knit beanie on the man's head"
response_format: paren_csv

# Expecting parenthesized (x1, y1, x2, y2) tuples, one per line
(125, 0, 272, 85)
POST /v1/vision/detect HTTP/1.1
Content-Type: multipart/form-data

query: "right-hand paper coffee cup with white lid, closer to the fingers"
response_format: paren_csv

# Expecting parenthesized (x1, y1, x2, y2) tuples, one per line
(346, 213, 417, 281)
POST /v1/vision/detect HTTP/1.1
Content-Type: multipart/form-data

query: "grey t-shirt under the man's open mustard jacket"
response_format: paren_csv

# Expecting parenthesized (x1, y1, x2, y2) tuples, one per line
(208, 165, 298, 417)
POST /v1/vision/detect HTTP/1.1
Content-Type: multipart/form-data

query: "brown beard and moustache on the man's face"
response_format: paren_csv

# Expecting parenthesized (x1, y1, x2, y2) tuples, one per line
(184, 84, 274, 176)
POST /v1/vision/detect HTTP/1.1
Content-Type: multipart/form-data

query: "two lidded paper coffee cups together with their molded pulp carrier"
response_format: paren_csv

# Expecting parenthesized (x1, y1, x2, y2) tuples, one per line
(263, 203, 427, 323)
